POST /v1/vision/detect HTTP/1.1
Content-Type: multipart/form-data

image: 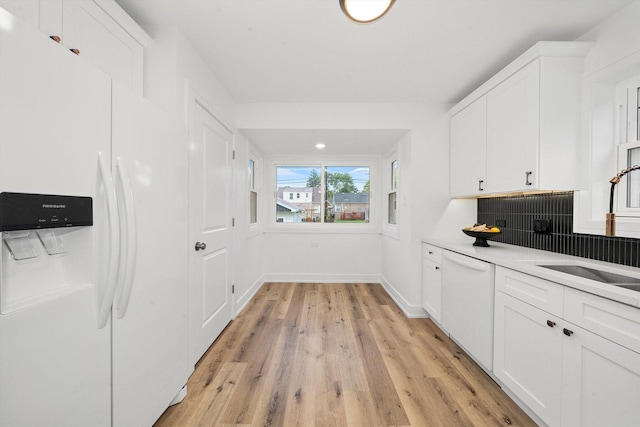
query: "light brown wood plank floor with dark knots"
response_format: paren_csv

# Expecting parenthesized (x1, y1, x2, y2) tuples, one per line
(155, 283, 535, 427)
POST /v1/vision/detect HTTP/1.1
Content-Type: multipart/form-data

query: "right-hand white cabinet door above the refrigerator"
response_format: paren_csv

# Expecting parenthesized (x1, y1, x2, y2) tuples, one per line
(62, 0, 143, 95)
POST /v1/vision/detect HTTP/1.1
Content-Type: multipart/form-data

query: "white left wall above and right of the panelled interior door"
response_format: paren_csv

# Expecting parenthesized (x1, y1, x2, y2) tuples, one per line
(144, 26, 264, 314)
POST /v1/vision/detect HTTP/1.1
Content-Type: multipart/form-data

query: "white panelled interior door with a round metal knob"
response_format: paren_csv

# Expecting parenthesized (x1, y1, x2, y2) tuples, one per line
(189, 100, 233, 363)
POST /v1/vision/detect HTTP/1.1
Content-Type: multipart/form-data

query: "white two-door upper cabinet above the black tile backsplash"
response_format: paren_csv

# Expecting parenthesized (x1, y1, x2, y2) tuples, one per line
(450, 42, 590, 197)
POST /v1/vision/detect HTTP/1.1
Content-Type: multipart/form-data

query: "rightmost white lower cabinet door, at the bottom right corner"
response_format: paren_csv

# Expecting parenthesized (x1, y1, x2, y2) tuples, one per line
(562, 322, 640, 427)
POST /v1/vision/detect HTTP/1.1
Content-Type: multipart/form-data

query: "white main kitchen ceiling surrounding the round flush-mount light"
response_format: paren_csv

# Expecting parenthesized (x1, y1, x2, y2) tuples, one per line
(116, 0, 632, 152)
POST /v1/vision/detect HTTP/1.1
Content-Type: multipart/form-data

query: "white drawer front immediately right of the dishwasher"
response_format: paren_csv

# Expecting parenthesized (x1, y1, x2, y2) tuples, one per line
(496, 266, 564, 317)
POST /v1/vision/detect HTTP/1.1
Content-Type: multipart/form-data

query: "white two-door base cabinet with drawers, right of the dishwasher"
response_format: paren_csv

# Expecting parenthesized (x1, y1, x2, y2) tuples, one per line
(494, 267, 640, 427)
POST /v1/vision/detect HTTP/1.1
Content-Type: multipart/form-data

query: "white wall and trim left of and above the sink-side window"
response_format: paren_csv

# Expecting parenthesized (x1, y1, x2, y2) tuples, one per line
(574, 1, 640, 238)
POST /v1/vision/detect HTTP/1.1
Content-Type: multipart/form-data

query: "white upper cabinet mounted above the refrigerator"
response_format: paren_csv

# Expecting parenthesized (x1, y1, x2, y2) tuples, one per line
(0, 0, 150, 95)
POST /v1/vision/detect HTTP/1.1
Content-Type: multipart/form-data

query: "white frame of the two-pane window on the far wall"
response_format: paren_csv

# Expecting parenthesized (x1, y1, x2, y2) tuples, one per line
(267, 156, 381, 233)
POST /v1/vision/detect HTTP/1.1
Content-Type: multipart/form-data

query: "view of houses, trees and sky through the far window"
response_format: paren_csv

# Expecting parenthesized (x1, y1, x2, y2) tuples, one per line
(276, 166, 370, 224)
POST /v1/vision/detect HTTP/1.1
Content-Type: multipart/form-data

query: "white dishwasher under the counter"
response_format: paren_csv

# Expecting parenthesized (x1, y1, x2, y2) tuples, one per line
(442, 250, 495, 371)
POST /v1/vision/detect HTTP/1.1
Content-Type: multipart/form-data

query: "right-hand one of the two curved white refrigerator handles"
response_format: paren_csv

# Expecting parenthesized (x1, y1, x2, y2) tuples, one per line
(116, 157, 138, 319)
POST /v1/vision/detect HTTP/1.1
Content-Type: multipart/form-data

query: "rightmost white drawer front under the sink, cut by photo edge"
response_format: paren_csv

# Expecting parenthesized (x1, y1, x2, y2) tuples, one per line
(564, 288, 640, 353)
